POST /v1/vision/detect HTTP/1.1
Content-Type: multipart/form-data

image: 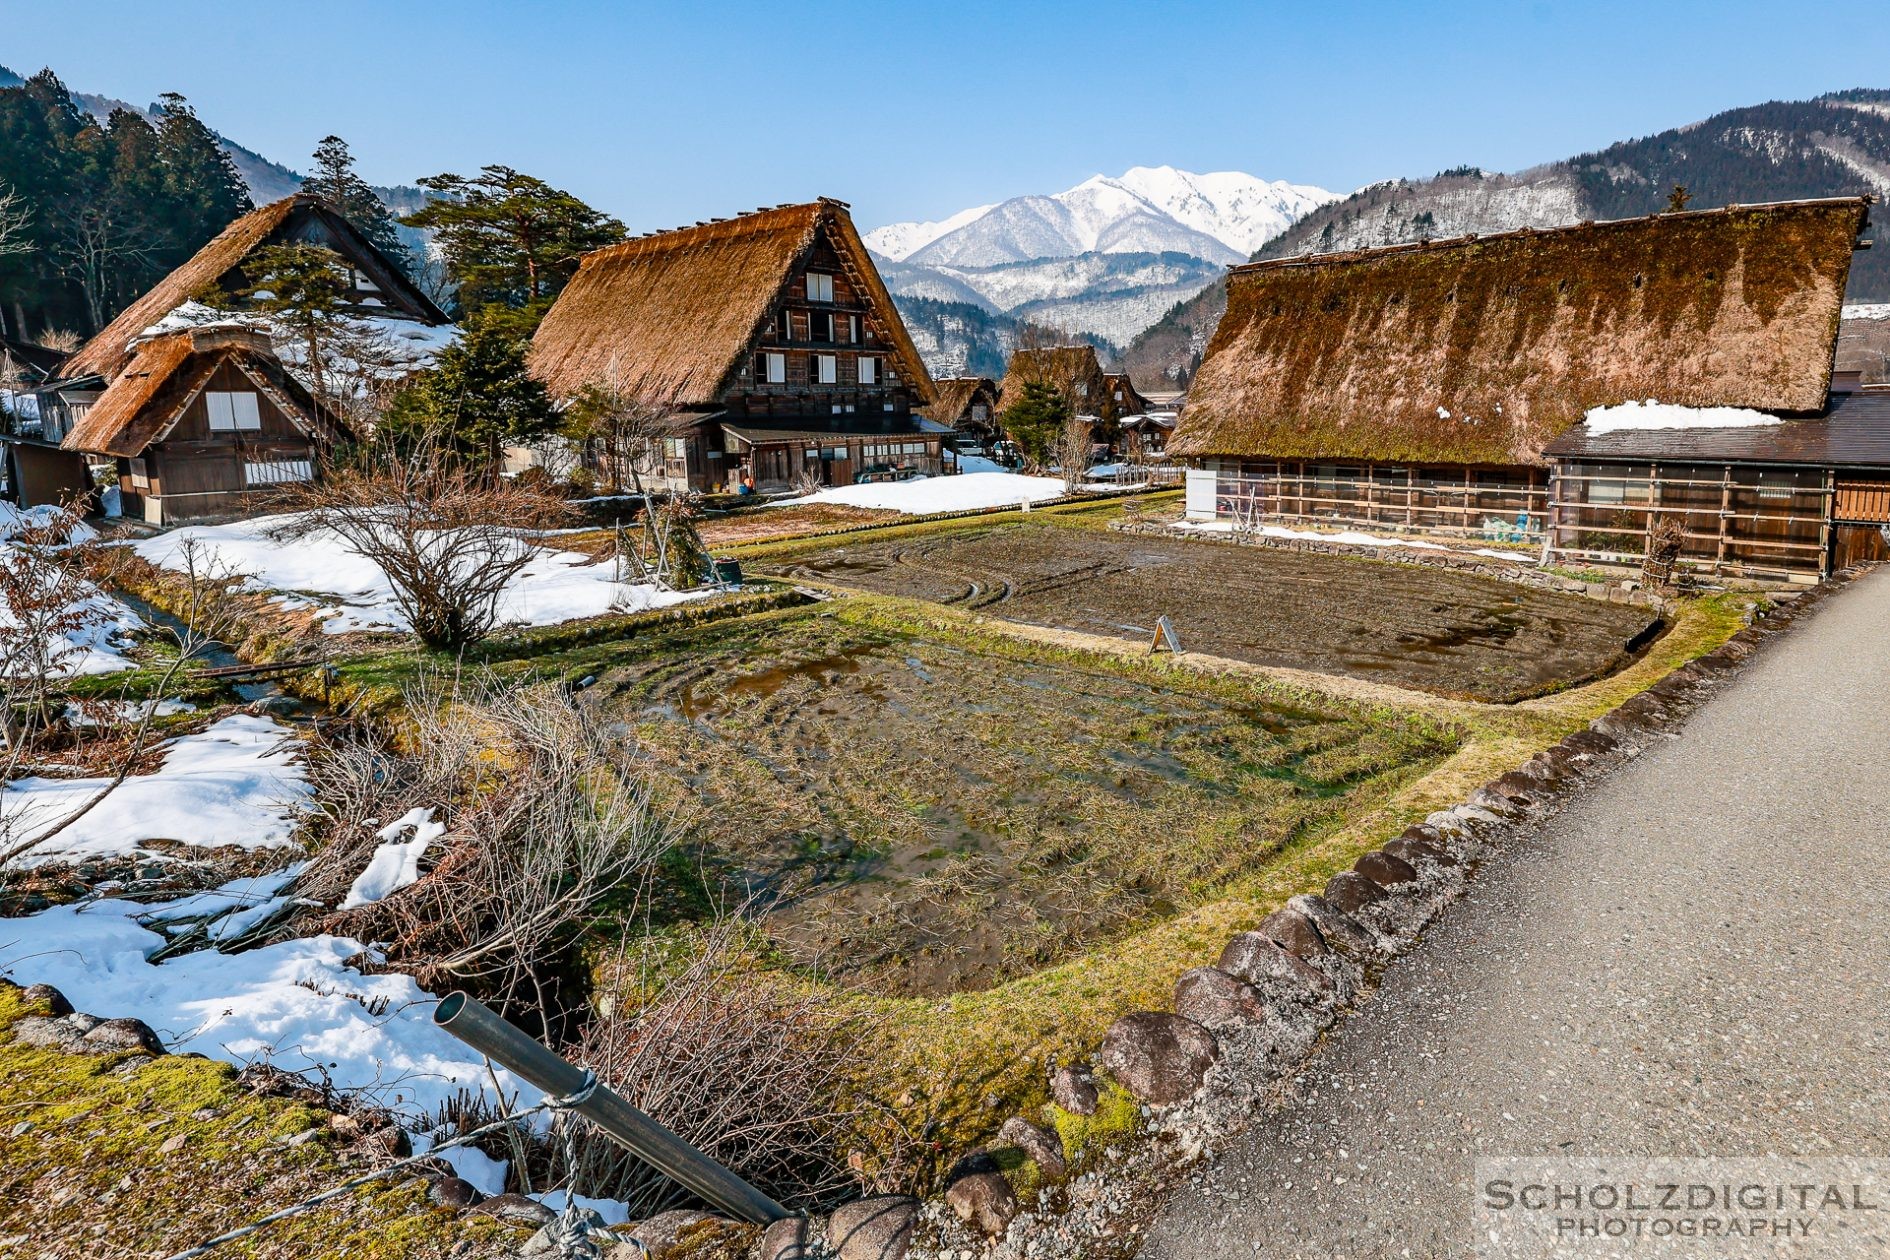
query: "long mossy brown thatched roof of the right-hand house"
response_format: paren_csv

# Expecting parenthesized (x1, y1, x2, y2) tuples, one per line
(1168, 196, 1869, 463)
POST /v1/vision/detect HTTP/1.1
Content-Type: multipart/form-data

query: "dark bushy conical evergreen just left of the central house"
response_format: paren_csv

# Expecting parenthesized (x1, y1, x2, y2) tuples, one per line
(382, 308, 558, 467)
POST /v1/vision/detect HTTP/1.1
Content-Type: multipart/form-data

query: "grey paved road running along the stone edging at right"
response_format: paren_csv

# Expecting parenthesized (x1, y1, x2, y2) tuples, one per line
(1143, 570, 1890, 1260)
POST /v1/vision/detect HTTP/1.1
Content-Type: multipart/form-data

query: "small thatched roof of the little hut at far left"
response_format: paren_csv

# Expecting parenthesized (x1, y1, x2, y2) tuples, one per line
(60, 327, 338, 457)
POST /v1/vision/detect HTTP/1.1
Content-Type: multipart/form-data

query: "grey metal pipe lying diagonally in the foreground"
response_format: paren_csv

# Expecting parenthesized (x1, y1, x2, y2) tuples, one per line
(433, 992, 794, 1224)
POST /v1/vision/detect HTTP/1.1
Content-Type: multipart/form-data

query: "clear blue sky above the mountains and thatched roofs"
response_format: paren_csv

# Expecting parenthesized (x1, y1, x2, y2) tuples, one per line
(0, 0, 1890, 230)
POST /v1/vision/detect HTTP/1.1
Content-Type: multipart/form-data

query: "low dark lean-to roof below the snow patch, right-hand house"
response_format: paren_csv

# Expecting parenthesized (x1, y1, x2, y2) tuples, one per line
(1546, 389, 1890, 468)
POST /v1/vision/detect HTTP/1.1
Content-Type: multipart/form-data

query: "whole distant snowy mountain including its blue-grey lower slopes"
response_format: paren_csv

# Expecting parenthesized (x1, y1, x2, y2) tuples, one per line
(866, 166, 1334, 370)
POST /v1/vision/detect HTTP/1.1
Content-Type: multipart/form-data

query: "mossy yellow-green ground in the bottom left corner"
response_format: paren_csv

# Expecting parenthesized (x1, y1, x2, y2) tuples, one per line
(0, 989, 524, 1260)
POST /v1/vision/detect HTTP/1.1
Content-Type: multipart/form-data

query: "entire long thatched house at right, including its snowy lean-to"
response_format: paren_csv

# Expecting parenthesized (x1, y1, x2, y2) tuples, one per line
(1168, 196, 1890, 580)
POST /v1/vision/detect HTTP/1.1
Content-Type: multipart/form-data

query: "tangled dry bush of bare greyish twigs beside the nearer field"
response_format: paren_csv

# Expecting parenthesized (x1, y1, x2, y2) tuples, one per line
(297, 680, 677, 1018)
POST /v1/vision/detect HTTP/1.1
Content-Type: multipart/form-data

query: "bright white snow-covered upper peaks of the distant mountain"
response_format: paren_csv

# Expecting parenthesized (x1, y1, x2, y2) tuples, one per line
(866, 166, 1334, 266)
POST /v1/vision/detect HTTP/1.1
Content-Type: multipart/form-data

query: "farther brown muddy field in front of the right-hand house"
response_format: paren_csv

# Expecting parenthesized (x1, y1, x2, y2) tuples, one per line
(777, 525, 1654, 701)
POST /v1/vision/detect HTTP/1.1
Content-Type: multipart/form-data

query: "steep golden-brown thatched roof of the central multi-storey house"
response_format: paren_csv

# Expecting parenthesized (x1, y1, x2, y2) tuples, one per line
(531, 198, 932, 406)
